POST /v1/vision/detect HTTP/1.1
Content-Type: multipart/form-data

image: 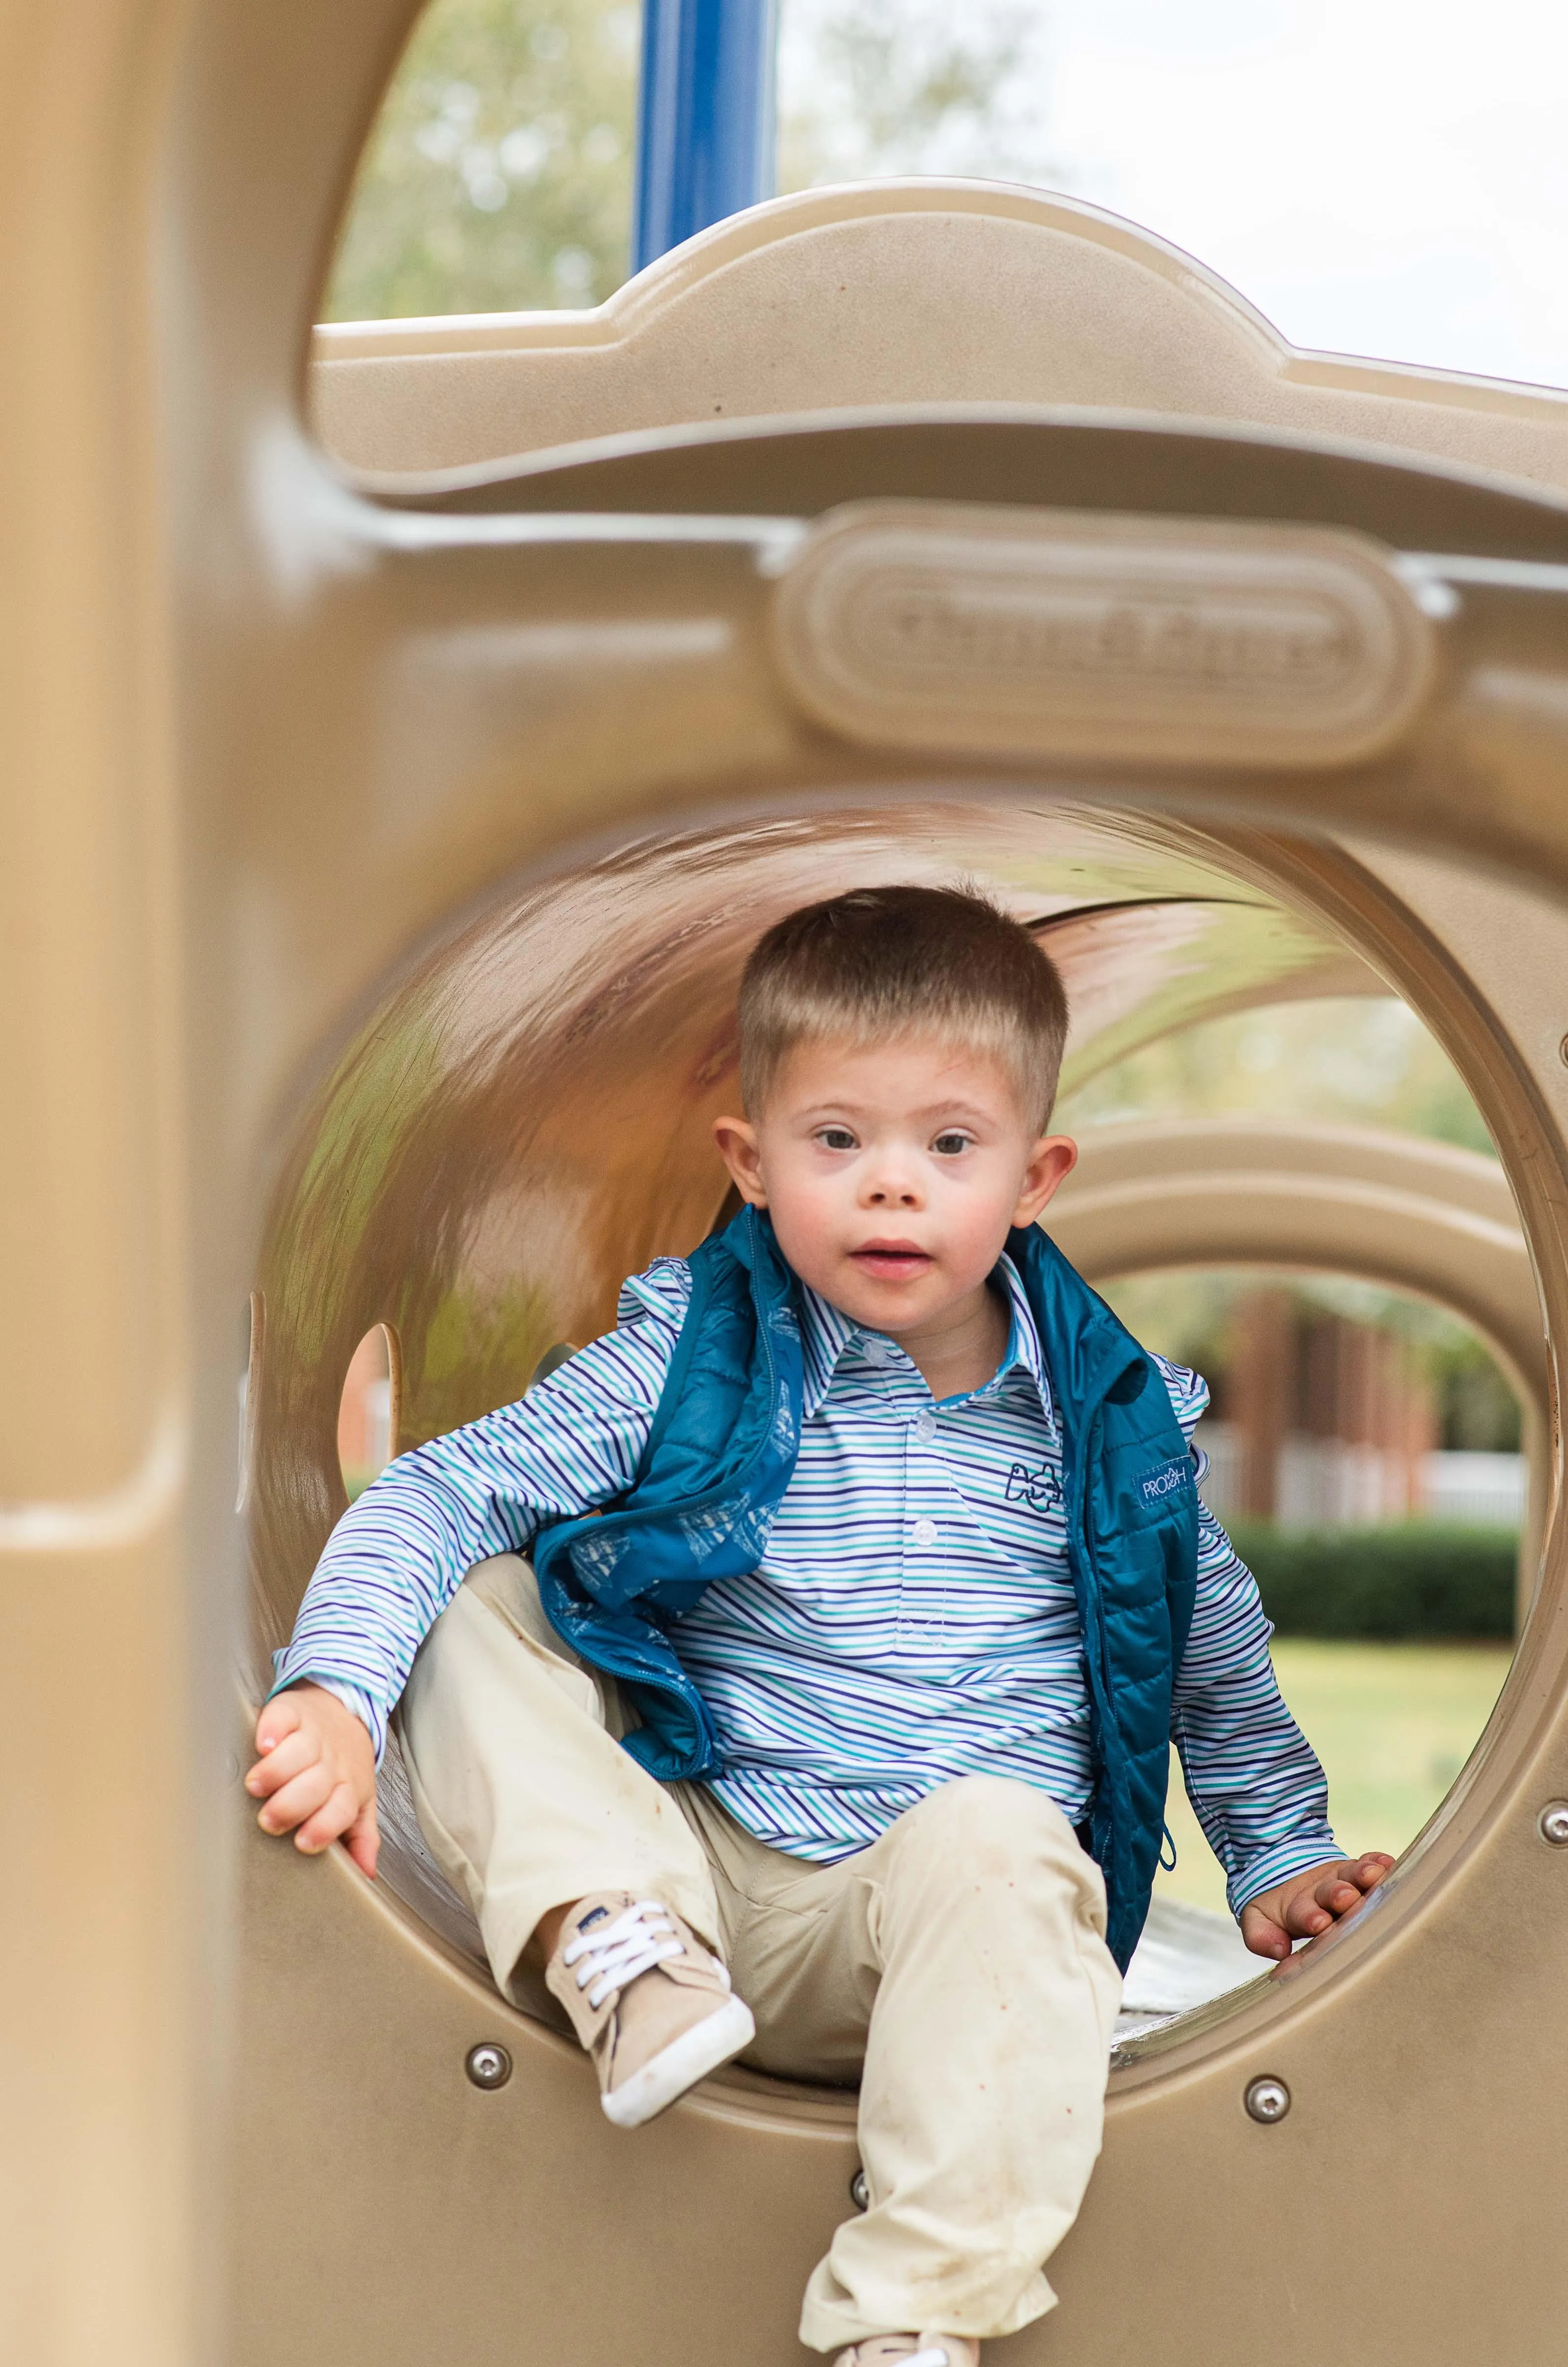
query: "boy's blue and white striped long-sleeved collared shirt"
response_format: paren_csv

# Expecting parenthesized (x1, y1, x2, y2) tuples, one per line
(277, 1257, 1338, 1910)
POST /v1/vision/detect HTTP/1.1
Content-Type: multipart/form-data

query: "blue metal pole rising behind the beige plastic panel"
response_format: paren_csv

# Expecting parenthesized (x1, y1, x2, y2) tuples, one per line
(633, 0, 777, 272)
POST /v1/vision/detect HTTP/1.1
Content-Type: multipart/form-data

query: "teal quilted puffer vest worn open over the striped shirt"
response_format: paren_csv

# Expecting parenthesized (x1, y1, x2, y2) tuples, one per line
(533, 1207, 1199, 1970)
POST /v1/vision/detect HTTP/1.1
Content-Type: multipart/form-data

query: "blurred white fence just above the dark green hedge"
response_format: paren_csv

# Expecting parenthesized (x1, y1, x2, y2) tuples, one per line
(1196, 1423, 1528, 1529)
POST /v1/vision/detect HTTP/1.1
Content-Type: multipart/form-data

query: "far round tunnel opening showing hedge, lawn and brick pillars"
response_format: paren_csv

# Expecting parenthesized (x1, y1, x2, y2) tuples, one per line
(1102, 1268, 1544, 2038)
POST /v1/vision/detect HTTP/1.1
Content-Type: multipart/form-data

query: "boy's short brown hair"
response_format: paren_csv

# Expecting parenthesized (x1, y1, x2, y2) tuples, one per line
(739, 888, 1068, 1131)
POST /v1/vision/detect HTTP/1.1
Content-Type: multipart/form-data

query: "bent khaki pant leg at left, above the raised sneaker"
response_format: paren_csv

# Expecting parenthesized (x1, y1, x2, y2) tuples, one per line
(398, 1553, 720, 2007)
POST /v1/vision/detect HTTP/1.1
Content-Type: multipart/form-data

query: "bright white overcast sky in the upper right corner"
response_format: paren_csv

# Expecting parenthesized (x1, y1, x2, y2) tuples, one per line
(1047, 0, 1568, 386)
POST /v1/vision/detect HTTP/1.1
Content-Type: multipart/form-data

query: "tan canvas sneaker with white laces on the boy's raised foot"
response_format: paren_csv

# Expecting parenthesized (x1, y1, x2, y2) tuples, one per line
(545, 1891, 755, 2128)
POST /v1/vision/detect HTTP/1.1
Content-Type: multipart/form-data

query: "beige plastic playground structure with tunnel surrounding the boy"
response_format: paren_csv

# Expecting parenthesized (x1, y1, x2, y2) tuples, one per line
(15, 0, 1568, 2367)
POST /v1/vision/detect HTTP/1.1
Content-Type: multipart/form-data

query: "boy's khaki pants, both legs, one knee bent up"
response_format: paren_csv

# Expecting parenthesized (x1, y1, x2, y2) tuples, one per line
(400, 1555, 1120, 2350)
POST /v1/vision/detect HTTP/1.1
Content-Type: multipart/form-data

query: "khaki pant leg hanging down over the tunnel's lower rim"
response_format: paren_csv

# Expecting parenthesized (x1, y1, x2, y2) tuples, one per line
(682, 1775, 1120, 2350)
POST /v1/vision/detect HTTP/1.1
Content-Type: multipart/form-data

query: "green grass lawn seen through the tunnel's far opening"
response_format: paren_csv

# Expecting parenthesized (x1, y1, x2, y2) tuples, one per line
(1158, 1636, 1514, 1910)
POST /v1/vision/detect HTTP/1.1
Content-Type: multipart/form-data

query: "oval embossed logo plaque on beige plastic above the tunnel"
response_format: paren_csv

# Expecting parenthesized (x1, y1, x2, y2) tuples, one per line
(775, 502, 1435, 767)
